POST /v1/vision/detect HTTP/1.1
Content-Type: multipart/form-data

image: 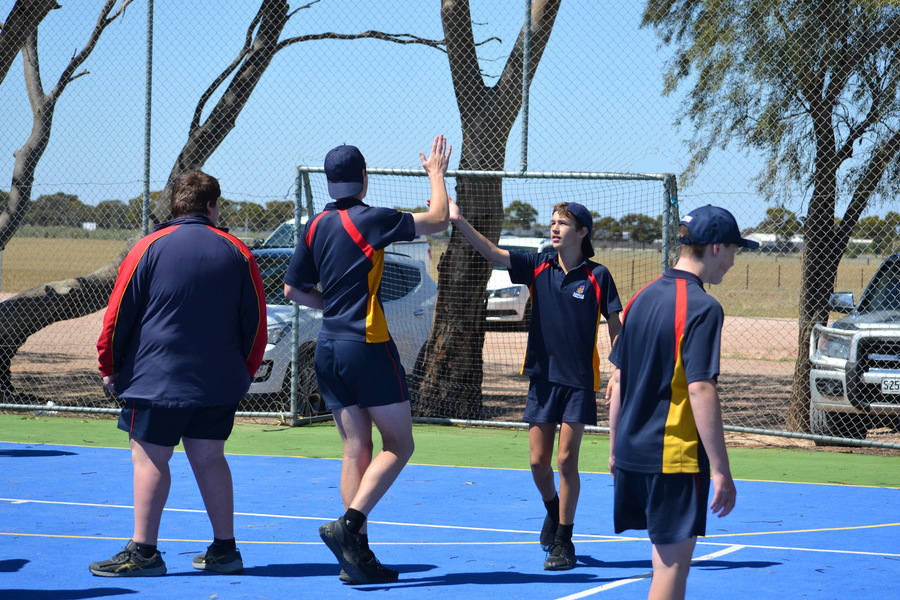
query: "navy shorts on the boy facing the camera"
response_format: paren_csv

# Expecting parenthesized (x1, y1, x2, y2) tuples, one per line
(522, 377, 597, 425)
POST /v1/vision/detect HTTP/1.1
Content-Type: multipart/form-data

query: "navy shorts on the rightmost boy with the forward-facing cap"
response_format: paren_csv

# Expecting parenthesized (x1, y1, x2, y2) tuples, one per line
(613, 468, 710, 544)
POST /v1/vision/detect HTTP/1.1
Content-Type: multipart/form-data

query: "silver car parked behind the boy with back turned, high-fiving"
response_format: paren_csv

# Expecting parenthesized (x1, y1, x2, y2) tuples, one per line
(248, 248, 437, 413)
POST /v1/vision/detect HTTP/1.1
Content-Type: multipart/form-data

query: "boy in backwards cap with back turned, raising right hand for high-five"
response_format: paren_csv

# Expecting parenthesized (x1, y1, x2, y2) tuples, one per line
(284, 135, 452, 583)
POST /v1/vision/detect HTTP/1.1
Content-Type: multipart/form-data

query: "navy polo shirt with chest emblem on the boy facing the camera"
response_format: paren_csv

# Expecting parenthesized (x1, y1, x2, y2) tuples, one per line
(509, 252, 622, 392)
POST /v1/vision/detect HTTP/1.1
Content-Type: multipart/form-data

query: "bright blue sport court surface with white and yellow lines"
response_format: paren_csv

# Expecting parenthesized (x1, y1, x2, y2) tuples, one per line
(0, 443, 900, 600)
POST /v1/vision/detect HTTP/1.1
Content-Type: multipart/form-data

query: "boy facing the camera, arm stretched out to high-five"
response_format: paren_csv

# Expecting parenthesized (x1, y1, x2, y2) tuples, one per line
(450, 202, 622, 571)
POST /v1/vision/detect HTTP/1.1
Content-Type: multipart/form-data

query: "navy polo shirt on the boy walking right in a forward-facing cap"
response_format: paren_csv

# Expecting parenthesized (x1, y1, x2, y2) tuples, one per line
(609, 269, 724, 473)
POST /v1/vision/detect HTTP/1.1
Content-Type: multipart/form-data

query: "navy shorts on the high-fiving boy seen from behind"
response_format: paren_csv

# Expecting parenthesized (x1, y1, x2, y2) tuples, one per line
(316, 338, 409, 410)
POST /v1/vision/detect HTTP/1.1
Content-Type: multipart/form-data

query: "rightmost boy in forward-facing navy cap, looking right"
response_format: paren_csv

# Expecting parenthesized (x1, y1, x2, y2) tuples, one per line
(609, 205, 759, 598)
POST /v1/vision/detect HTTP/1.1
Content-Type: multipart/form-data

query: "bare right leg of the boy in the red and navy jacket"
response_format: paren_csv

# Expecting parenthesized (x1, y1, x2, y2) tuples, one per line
(182, 437, 234, 540)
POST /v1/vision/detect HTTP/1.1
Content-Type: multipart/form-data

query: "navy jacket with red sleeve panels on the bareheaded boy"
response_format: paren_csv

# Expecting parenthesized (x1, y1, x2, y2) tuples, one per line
(97, 217, 266, 407)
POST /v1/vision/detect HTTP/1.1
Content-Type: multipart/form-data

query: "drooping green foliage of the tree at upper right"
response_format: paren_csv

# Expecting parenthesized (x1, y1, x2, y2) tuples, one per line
(642, 0, 900, 206)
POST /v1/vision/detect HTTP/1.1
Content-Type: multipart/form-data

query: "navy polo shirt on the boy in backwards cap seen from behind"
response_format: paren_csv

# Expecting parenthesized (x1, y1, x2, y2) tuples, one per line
(284, 198, 416, 343)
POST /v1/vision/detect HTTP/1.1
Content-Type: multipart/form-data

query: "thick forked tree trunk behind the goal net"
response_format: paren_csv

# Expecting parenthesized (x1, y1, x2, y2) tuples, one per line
(411, 0, 560, 419)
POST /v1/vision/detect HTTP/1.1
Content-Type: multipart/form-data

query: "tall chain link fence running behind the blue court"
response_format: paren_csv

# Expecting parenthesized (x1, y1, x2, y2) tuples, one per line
(0, 0, 900, 447)
